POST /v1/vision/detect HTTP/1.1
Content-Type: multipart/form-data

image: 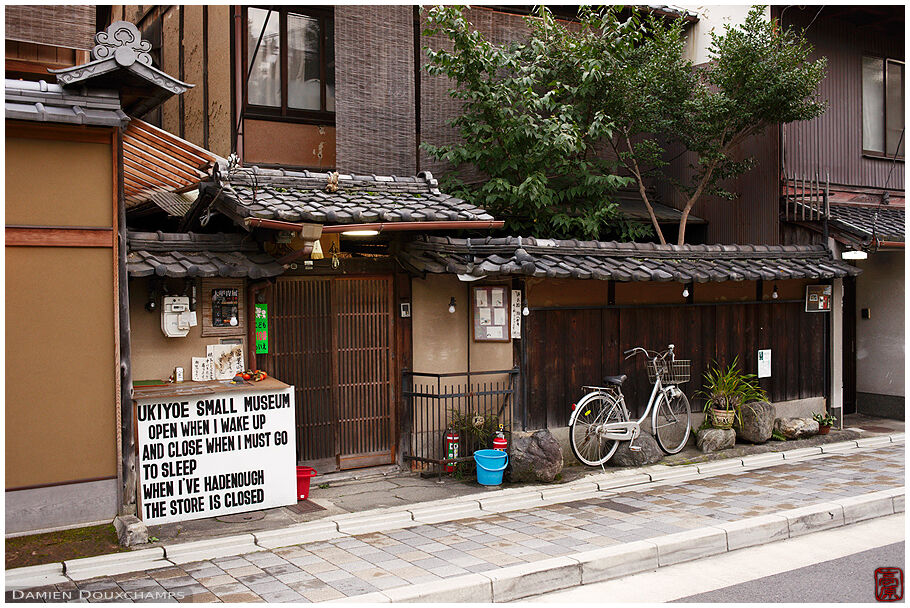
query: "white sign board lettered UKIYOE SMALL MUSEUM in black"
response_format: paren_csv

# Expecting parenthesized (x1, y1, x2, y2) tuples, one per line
(136, 387, 297, 525)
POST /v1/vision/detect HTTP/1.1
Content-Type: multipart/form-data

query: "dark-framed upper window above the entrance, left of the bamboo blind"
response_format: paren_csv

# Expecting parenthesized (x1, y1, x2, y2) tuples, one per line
(243, 7, 335, 124)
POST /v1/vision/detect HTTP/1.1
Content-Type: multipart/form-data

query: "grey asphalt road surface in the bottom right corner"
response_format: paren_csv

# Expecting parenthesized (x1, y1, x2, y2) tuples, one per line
(676, 543, 904, 603)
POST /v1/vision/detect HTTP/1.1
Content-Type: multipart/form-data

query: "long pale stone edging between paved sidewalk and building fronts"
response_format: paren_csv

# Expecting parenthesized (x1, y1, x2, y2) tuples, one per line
(6, 433, 904, 602)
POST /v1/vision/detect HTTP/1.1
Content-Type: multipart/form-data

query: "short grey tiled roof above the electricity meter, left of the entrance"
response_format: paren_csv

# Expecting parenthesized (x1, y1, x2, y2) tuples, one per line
(126, 231, 284, 279)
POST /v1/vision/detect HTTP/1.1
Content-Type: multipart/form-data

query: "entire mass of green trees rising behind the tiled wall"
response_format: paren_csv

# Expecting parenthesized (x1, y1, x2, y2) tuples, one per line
(422, 6, 826, 244)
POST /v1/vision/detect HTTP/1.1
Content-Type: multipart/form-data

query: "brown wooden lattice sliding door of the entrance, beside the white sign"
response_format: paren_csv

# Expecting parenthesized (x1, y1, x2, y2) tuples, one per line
(269, 277, 394, 472)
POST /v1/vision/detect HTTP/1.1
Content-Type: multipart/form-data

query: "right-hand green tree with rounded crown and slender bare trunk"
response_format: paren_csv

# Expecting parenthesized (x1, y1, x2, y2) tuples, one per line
(665, 6, 826, 245)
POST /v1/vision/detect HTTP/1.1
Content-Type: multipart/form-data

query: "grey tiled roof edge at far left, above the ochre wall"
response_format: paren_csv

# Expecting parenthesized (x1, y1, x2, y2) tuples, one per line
(6, 79, 130, 127)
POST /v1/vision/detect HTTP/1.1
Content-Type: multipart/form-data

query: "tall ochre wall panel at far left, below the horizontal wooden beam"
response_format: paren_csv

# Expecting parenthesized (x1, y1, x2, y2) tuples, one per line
(4, 245, 117, 488)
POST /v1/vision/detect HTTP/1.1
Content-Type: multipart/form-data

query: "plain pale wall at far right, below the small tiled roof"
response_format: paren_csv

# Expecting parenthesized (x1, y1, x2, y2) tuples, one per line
(856, 251, 905, 396)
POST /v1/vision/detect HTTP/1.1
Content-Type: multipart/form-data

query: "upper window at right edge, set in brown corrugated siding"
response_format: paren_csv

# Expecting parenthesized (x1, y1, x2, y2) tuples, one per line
(863, 57, 905, 158)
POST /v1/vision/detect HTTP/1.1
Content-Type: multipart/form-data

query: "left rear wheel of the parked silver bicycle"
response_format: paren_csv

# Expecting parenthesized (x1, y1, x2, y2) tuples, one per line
(569, 393, 625, 467)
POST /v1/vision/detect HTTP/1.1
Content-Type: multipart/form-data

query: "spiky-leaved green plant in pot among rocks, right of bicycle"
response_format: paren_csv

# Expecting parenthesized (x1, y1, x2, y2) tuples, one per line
(698, 356, 768, 429)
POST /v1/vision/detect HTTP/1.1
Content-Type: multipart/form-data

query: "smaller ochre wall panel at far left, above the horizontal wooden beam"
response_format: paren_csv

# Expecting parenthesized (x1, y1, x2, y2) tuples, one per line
(5, 137, 114, 227)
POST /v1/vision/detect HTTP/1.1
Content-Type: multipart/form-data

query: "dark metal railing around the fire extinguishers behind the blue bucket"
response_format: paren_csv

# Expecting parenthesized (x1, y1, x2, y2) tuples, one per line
(401, 367, 518, 475)
